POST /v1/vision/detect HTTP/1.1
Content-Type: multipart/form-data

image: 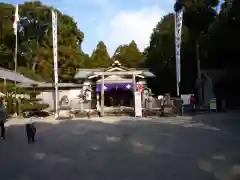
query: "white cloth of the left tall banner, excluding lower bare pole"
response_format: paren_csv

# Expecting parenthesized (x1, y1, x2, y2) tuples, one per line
(52, 10, 58, 85)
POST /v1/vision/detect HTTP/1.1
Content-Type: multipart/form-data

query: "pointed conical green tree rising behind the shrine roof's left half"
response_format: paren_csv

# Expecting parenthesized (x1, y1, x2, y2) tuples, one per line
(88, 41, 112, 68)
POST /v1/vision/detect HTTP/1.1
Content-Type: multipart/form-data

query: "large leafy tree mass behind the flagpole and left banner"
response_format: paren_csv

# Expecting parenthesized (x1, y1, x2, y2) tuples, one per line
(0, 1, 84, 82)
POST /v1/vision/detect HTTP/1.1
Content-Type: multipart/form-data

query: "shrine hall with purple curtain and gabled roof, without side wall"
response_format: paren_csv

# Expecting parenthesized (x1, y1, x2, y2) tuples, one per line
(75, 60, 155, 108)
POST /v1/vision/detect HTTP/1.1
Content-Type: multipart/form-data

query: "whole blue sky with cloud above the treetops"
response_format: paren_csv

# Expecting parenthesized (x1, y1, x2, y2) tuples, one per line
(4, 0, 223, 55)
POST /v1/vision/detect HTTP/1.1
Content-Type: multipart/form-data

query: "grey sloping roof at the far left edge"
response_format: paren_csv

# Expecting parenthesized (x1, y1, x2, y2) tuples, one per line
(0, 68, 37, 84)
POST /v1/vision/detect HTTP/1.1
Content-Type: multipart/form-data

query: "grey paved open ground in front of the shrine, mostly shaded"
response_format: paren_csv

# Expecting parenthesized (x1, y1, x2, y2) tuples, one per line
(0, 115, 240, 180)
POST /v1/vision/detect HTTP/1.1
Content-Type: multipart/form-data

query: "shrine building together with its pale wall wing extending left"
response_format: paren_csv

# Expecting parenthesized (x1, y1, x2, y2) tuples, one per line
(15, 61, 155, 114)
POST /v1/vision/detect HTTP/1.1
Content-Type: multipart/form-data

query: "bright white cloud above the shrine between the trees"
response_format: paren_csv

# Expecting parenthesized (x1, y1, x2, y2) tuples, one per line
(98, 6, 165, 54)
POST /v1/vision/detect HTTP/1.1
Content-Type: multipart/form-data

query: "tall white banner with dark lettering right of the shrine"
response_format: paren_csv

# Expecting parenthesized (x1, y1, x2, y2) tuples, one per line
(175, 9, 183, 96)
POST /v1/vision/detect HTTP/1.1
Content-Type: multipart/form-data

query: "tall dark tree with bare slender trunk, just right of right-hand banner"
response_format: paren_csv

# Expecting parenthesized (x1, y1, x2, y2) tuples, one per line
(174, 0, 219, 104)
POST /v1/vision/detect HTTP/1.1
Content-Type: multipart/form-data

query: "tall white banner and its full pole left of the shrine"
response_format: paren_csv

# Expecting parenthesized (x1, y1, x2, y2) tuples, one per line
(52, 10, 58, 117)
